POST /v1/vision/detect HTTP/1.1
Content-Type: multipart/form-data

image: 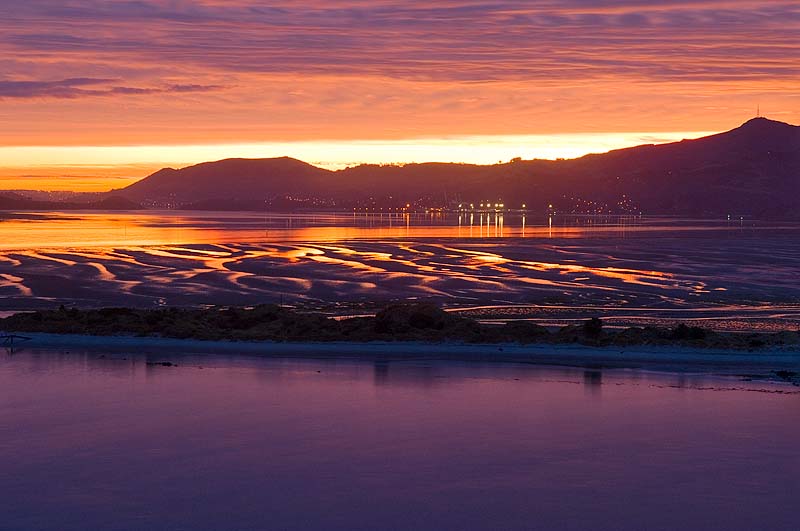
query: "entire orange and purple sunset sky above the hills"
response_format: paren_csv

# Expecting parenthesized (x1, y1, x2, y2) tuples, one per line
(0, 0, 800, 190)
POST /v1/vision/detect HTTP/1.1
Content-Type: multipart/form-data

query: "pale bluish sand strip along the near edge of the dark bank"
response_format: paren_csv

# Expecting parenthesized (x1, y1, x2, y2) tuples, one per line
(12, 334, 800, 373)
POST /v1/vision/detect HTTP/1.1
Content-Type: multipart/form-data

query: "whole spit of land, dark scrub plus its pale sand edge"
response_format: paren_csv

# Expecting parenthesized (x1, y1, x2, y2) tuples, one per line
(0, 303, 800, 385)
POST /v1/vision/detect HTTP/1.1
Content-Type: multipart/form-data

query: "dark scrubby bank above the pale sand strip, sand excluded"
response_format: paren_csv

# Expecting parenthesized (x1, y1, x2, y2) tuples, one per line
(0, 303, 800, 350)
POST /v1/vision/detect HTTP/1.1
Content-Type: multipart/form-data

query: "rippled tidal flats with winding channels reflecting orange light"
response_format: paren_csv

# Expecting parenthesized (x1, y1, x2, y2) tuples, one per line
(0, 239, 800, 310)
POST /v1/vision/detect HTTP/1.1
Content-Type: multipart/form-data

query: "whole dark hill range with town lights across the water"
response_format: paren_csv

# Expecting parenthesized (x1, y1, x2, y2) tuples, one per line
(116, 118, 800, 218)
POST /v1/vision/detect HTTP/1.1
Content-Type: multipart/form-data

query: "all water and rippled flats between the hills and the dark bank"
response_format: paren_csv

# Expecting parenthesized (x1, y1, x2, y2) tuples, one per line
(0, 212, 800, 330)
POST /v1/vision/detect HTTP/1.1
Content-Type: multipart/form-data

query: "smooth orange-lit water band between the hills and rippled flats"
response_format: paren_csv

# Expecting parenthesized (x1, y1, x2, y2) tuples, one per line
(0, 211, 797, 250)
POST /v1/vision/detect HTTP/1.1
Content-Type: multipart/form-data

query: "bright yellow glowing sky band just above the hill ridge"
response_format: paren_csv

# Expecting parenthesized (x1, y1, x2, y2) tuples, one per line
(0, 132, 709, 191)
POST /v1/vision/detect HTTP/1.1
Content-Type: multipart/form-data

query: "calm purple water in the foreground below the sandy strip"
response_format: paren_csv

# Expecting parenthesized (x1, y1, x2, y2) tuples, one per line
(0, 350, 800, 531)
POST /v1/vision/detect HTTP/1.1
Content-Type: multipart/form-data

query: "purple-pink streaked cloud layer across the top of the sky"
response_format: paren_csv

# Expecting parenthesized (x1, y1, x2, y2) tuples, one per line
(0, 0, 800, 81)
